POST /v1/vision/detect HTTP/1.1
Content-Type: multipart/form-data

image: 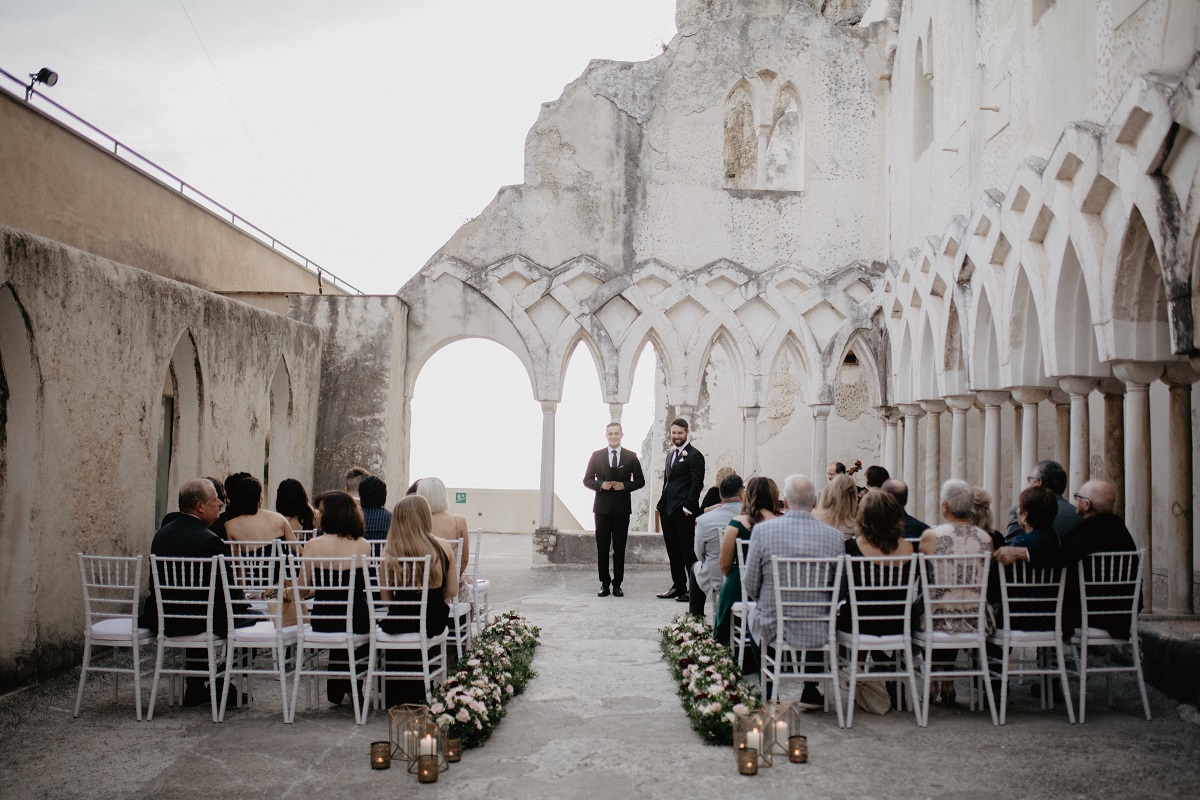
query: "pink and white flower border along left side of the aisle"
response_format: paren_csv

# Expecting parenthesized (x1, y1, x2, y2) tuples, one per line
(430, 612, 541, 748)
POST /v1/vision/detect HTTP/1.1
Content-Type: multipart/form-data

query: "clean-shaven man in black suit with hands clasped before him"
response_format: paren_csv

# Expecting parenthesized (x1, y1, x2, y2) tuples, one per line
(583, 422, 646, 597)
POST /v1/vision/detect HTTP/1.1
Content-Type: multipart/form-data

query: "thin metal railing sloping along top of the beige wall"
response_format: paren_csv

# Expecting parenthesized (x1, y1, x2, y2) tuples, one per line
(0, 68, 362, 294)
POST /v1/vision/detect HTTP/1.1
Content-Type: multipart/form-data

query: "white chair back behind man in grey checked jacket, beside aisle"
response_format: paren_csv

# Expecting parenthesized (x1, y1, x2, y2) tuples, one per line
(770, 555, 846, 649)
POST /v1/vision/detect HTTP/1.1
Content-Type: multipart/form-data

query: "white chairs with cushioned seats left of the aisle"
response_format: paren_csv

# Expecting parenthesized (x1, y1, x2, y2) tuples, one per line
(74, 530, 490, 723)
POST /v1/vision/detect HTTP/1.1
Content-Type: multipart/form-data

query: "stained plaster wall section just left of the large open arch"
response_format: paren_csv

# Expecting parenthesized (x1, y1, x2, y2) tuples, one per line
(290, 295, 408, 498)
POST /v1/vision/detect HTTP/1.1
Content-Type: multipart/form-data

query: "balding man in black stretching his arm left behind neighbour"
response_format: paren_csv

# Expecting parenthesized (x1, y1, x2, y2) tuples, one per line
(996, 481, 1141, 639)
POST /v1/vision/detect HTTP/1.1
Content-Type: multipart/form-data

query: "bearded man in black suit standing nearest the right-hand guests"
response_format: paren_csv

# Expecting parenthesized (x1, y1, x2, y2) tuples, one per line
(658, 419, 704, 602)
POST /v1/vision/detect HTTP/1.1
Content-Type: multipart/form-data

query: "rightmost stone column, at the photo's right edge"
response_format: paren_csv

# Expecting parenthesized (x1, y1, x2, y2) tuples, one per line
(1163, 361, 1200, 614)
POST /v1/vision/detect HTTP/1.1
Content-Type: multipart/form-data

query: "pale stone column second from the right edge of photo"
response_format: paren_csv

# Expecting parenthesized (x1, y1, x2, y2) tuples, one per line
(1112, 361, 1163, 613)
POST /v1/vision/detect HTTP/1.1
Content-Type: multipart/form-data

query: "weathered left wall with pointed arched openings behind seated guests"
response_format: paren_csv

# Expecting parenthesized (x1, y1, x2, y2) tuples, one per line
(0, 227, 320, 684)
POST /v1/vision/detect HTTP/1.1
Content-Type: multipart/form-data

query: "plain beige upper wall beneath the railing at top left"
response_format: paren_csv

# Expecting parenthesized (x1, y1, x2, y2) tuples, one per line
(0, 92, 344, 295)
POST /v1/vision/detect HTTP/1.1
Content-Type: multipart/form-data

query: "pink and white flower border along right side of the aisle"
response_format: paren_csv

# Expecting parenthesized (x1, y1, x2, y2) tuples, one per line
(661, 614, 762, 745)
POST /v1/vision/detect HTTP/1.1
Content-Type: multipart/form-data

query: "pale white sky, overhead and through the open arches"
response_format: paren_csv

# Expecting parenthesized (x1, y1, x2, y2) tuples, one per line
(0, 0, 676, 527)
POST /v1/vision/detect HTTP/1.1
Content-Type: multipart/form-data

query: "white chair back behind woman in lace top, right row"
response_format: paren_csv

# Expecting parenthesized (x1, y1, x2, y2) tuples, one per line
(918, 553, 991, 636)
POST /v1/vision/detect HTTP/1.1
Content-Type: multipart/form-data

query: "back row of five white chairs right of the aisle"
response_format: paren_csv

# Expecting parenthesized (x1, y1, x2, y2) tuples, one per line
(761, 551, 1151, 727)
